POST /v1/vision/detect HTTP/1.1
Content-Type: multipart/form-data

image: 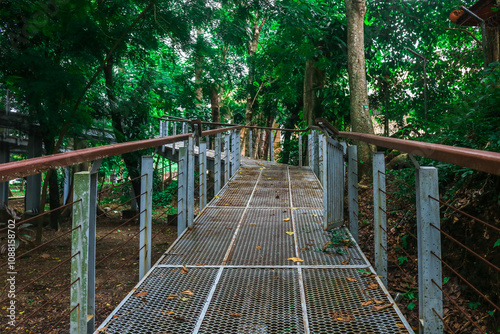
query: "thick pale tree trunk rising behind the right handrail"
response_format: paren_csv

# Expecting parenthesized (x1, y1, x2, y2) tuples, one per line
(345, 0, 373, 175)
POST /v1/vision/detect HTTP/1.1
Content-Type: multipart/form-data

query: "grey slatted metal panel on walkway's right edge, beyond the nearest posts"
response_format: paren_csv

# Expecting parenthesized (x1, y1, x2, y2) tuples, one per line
(321, 135, 345, 230)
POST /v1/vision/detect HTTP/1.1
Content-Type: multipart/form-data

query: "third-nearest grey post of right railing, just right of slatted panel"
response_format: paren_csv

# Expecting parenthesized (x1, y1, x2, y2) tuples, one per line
(347, 145, 359, 242)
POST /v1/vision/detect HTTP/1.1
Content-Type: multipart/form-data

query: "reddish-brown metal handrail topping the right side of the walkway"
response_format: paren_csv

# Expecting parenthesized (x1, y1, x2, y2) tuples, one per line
(316, 118, 500, 175)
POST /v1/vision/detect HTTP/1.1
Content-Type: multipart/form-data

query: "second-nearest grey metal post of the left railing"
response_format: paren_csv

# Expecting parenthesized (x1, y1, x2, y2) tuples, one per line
(139, 155, 154, 280)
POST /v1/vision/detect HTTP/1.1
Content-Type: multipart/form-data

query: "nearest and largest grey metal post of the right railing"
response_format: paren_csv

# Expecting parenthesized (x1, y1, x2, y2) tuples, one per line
(416, 167, 443, 334)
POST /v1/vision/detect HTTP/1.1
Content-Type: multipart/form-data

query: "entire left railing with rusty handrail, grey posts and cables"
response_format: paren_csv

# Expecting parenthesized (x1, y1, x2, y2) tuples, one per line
(0, 124, 242, 333)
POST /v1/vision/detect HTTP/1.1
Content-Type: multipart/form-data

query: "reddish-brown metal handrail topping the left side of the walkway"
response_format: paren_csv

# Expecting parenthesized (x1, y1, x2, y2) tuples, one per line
(0, 126, 243, 182)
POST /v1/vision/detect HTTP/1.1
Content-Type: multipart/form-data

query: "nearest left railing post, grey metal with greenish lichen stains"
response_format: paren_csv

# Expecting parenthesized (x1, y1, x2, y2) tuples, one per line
(70, 172, 90, 334)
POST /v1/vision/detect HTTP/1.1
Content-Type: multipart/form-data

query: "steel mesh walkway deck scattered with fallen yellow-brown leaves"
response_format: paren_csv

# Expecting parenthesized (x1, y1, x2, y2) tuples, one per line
(97, 162, 413, 334)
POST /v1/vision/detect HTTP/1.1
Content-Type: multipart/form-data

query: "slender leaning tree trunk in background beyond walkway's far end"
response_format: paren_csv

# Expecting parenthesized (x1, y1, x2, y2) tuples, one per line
(241, 13, 266, 155)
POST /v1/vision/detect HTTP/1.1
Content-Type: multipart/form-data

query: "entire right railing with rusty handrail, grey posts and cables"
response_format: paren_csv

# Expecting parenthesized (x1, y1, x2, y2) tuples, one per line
(316, 119, 500, 334)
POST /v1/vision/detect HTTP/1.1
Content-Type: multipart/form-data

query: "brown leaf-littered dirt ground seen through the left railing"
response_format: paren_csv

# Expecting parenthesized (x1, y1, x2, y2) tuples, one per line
(0, 200, 177, 333)
